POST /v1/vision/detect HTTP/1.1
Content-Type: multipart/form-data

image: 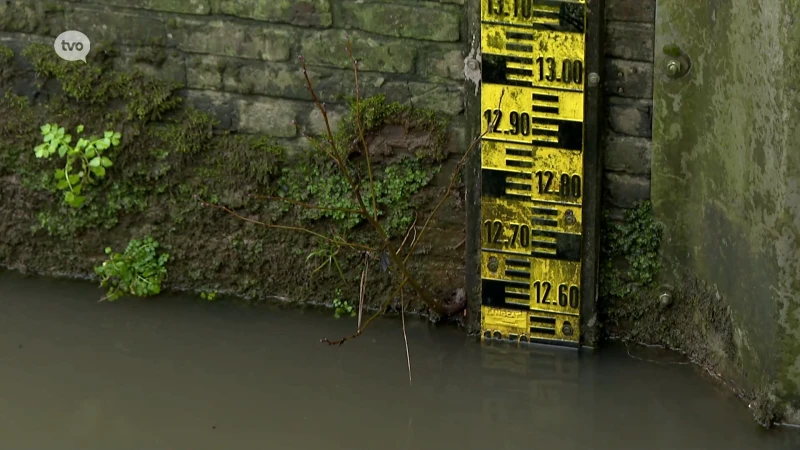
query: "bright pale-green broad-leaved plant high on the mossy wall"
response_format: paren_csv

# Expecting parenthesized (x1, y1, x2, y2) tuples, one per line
(34, 123, 122, 208)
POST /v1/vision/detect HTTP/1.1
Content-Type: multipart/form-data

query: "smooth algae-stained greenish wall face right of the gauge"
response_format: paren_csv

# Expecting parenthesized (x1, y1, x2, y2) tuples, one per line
(652, 0, 800, 426)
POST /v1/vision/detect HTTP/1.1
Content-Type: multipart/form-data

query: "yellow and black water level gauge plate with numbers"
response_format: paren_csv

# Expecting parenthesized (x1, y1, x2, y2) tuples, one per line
(481, 0, 586, 345)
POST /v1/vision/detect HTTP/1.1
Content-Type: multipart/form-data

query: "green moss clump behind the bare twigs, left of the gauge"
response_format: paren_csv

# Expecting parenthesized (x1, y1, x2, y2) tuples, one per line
(281, 96, 447, 236)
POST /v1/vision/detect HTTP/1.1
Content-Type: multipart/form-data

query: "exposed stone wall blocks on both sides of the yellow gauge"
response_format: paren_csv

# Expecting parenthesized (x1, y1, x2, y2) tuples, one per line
(0, 0, 655, 316)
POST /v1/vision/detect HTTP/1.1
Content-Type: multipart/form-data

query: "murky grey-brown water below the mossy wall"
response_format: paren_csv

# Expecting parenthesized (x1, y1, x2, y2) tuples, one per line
(0, 274, 800, 450)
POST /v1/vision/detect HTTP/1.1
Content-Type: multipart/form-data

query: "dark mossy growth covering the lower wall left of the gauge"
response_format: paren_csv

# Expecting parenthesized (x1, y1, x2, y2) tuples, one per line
(0, 40, 463, 318)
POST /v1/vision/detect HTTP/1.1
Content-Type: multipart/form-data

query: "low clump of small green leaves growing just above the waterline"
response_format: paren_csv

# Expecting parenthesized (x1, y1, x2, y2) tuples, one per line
(94, 236, 169, 301)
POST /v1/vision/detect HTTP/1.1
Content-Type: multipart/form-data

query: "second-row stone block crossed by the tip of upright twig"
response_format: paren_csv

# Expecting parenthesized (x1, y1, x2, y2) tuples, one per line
(300, 30, 418, 73)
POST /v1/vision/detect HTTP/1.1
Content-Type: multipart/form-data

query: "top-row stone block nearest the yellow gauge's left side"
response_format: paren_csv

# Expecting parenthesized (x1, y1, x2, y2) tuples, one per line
(335, 2, 460, 42)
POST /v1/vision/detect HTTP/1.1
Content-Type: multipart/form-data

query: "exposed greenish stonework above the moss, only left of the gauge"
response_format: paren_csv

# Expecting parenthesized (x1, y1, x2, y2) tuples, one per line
(0, 0, 465, 145)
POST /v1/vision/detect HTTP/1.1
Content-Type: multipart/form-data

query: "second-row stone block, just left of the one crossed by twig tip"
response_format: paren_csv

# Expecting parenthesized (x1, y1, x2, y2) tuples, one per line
(170, 18, 297, 61)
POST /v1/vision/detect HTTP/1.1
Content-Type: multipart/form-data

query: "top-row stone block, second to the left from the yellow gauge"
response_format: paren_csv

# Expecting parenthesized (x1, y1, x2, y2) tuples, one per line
(211, 0, 332, 27)
